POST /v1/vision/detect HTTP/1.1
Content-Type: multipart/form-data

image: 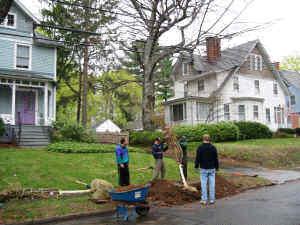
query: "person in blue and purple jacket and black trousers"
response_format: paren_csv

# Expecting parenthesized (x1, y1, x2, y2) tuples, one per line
(116, 138, 130, 186)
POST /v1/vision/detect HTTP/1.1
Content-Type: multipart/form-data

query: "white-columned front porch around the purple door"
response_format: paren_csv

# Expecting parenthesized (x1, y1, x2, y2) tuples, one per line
(0, 77, 56, 126)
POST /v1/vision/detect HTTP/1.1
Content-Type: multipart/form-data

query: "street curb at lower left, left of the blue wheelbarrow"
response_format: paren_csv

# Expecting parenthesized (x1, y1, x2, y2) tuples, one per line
(3, 210, 114, 225)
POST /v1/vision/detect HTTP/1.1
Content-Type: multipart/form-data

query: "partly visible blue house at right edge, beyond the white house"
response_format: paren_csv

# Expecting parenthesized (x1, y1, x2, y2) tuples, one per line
(279, 70, 300, 128)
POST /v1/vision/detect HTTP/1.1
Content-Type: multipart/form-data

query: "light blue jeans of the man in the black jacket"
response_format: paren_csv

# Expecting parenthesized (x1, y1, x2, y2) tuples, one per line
(200, 169, 216, 201)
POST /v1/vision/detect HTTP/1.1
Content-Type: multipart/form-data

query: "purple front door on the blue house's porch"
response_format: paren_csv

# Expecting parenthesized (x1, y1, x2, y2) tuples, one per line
(16, 91, 35, 125)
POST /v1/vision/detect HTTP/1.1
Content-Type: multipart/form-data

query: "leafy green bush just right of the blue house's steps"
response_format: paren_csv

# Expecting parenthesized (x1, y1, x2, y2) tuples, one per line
(51, 121, 95, 143)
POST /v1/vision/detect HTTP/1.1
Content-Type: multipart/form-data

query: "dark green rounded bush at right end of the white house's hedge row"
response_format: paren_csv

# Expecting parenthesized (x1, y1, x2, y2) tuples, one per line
(235, 121, 272, 140)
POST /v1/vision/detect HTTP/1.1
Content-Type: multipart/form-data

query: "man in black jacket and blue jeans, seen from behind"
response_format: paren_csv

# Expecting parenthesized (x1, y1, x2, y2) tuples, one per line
(195, 134, 219, 204)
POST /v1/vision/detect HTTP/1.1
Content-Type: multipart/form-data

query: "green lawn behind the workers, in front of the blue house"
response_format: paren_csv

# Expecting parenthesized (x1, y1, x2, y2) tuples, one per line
(0, 149, 198, 191)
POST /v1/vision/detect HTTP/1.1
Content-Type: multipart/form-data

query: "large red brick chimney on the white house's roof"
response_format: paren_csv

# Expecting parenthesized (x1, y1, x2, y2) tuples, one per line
(206, 36, 221, 63)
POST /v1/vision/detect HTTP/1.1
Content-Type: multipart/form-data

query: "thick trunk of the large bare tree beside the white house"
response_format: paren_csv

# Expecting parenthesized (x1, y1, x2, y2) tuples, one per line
(142, 71, 155, 130)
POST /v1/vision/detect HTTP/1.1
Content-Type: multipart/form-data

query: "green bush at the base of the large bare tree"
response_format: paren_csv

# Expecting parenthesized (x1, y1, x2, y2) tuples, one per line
(129, 131, 163, 146)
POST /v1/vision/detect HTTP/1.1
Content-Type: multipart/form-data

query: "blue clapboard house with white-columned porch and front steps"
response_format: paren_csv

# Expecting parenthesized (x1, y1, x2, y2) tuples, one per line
(0, 0, 58, 146)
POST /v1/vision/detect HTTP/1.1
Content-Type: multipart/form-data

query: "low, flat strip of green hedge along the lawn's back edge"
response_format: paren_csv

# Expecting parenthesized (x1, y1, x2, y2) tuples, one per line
(47, 142, 138, 153)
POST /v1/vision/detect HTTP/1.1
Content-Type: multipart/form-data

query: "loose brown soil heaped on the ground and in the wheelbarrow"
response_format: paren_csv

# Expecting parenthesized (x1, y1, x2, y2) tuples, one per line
(116, 175, 240, 206)
